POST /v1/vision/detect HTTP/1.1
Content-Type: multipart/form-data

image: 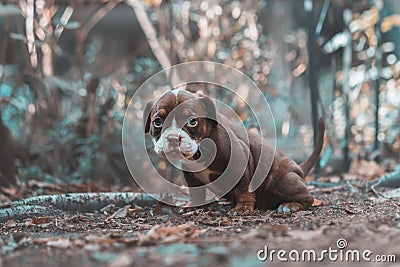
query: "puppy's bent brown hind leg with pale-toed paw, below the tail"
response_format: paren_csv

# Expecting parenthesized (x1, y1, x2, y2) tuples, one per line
(276, 172, 314, 213)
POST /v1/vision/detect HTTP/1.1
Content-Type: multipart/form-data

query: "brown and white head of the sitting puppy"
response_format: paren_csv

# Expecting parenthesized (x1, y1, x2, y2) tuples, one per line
(143, 89, 218, 159)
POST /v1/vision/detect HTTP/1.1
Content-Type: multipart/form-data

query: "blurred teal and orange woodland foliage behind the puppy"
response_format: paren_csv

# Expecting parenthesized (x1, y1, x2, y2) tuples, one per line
(0, 0, 400, 186)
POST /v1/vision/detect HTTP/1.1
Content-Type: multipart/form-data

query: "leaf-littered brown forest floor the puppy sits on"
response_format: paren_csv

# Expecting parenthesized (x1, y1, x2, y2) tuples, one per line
(0, 177, 400, 266)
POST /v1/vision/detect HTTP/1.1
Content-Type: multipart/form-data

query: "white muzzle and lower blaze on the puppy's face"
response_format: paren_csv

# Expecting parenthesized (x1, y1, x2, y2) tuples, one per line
(152, 116, 199, 158)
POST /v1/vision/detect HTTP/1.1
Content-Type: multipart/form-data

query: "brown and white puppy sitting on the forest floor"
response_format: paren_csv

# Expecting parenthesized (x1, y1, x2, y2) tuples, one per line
(144, 89, 325, 213)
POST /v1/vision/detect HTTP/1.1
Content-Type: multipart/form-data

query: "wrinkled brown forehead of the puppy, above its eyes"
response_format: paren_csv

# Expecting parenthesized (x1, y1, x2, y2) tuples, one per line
(152, 90, 206, 116)
